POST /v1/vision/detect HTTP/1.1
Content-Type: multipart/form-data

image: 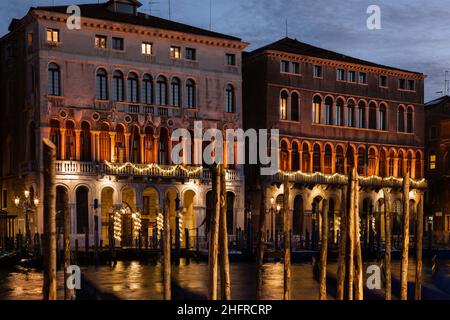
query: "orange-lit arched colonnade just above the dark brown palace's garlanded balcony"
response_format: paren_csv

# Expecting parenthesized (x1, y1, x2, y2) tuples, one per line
(279, 138, 424, 179)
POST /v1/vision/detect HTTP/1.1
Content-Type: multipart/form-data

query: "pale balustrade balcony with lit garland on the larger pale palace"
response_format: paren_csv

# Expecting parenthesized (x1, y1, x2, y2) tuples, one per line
(56, 161, 241, 181)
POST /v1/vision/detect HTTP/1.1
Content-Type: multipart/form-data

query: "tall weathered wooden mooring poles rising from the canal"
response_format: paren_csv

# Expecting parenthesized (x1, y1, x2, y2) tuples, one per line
(43, 139, 423, 300)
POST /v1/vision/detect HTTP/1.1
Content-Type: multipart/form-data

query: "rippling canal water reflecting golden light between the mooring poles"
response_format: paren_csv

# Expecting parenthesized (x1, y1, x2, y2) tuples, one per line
(0, 259, 450, 300)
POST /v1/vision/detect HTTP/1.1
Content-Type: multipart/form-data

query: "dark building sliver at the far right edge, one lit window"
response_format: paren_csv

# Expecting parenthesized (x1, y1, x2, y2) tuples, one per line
(425, 96, 450, 244)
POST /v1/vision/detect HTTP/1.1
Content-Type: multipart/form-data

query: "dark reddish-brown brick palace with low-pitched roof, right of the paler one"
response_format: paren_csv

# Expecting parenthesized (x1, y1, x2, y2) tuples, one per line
(243, 38, 426, 248)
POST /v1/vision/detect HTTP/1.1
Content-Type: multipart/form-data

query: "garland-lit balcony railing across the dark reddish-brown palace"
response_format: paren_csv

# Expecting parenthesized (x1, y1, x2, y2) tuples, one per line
(269, 172, 427, 190)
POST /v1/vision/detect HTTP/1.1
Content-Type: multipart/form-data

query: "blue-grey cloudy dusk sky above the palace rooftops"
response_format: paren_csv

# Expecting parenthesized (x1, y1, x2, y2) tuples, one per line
(0, 0, 450, 101)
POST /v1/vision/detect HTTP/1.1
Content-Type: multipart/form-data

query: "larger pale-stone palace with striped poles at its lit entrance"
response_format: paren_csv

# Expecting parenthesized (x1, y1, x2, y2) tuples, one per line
(0, 0, 247, 246)
